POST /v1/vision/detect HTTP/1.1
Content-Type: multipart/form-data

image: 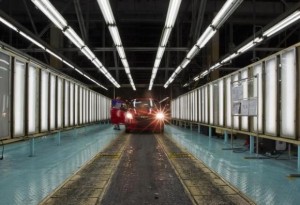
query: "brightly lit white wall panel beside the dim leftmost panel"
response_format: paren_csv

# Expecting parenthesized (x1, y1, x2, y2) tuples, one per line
(13, 60, 25, 136)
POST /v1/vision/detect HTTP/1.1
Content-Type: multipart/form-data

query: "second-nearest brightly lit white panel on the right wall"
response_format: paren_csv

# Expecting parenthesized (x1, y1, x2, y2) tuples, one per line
(265, 57, 278, 135)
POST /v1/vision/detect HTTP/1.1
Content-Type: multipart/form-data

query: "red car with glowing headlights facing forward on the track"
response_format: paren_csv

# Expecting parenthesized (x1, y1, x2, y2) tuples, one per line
(125, 98, 165, 132)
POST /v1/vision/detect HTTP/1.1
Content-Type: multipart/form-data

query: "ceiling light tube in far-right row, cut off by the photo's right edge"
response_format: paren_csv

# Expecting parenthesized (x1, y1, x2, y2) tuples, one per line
(263, 10, 300, 37)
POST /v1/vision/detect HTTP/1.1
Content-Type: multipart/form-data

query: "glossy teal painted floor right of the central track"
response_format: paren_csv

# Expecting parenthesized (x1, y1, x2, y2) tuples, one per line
(165, 126, 300, 205)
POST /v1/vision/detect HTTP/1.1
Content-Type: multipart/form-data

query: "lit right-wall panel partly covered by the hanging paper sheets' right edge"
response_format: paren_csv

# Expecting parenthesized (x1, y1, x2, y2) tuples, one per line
(252, 63, 263, 132)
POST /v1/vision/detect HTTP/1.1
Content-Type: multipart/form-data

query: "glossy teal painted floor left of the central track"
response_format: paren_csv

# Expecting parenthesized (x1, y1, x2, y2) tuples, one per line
(0, 124, 120, 205)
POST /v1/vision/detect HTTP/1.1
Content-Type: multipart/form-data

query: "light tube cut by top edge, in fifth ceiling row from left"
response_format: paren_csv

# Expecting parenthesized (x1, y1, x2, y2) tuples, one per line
(212, 0, 243, 29)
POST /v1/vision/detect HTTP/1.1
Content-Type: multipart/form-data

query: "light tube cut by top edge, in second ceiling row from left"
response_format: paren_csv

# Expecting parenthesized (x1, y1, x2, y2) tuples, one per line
(31, 0, 67, 30)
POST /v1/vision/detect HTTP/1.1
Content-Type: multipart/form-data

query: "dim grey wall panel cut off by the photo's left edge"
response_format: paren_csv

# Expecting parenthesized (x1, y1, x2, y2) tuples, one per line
(0, 52, 10, 139)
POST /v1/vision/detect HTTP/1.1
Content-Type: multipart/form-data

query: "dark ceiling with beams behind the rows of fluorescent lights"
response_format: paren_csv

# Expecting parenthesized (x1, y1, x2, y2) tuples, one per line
(0, 0, 300, 99)
